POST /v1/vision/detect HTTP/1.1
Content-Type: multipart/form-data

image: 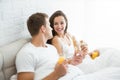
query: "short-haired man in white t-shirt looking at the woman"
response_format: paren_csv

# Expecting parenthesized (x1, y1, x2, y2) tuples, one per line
(13, 13, 81, 80)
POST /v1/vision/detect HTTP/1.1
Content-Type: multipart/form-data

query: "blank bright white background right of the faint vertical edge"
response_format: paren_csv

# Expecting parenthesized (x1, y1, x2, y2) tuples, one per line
(83, 0, 120, 49)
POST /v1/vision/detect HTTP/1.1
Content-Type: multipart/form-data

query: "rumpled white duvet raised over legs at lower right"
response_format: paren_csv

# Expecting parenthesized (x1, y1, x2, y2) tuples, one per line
(63, 48, 120, 80)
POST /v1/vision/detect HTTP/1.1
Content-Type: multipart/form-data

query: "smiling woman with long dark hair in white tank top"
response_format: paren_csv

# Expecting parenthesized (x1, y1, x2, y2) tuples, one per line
(48, 10, 87, 63)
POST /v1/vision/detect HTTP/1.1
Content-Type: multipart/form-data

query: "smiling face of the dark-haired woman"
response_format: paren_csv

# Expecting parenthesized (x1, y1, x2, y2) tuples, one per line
(53, 16, 66, 35)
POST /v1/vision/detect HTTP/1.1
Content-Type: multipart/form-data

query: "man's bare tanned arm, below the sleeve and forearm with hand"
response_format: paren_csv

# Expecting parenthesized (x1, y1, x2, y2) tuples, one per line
(17, 62, 67, 80)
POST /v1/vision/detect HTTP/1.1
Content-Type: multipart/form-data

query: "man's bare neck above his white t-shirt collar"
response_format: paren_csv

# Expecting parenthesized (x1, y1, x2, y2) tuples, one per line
(31, 36, 46, 47)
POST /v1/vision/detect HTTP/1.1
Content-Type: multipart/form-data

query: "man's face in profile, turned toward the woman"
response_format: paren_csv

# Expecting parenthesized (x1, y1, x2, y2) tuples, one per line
(45, 18, 53, 39)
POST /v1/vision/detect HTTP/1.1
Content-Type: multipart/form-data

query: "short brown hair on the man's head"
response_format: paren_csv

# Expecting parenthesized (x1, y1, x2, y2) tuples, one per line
(27, 13, 48, 36)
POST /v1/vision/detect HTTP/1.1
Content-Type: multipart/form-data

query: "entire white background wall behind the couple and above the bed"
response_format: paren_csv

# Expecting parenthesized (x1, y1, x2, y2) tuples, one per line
(0, 0, 120, 50)
